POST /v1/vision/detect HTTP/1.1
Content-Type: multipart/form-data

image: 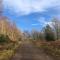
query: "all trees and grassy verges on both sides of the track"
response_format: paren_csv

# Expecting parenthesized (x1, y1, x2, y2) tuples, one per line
(0, 17, 60, 60)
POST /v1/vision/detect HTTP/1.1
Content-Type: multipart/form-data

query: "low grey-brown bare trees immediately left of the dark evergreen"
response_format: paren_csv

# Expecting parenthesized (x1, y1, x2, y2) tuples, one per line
(31, 30, 44, 41)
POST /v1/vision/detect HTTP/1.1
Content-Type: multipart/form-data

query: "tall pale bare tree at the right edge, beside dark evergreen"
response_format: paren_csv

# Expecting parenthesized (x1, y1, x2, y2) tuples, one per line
(52, 18, 60, 40)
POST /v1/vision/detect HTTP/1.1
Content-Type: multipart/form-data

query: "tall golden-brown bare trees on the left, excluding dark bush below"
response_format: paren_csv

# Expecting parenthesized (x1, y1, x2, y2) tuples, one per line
(0, 17, 22, 41)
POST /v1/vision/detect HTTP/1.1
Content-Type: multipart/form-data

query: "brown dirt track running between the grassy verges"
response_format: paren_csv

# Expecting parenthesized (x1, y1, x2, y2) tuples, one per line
(10, 42, 53, 60)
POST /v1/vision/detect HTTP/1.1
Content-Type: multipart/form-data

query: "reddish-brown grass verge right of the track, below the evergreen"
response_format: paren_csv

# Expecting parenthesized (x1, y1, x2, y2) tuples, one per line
(33, 41, 60, 60)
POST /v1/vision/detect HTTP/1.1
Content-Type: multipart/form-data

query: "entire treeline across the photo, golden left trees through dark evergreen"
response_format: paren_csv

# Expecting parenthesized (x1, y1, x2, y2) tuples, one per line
(0, 17, 60, 42)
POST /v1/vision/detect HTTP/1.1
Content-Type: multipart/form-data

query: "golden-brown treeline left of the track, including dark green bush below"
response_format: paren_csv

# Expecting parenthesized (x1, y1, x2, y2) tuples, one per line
(0, 17, 21, 43)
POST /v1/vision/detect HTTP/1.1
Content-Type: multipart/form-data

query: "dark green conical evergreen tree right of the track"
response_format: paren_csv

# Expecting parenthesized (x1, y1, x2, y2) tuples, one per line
(44, 25, 55, 41)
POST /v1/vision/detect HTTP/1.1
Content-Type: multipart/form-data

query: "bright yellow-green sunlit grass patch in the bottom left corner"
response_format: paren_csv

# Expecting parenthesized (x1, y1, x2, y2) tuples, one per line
(0, 50, 14, 60)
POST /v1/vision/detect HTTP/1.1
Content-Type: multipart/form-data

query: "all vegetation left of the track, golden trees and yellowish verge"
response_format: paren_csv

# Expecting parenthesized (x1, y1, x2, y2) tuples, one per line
(0, 17, 22, 60)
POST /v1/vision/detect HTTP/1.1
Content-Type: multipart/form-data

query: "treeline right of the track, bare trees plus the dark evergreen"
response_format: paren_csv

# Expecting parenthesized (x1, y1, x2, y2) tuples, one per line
(23, 18, 60, 41)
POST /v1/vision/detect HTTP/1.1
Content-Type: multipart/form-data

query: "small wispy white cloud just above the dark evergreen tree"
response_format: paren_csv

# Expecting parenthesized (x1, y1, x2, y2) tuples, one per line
(32, 17, 53, 27)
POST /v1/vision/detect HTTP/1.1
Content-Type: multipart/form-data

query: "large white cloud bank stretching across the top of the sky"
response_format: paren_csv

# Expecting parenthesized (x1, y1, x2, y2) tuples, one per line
(3, 0, 60, 15)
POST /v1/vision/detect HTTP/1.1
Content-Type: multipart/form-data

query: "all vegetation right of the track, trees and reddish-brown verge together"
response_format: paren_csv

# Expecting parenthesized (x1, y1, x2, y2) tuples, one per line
(22, 18, 60, 60)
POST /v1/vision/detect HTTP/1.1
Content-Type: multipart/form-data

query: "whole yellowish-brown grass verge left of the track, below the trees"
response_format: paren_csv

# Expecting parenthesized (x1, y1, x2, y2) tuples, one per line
(0, 43, 20, 60)
